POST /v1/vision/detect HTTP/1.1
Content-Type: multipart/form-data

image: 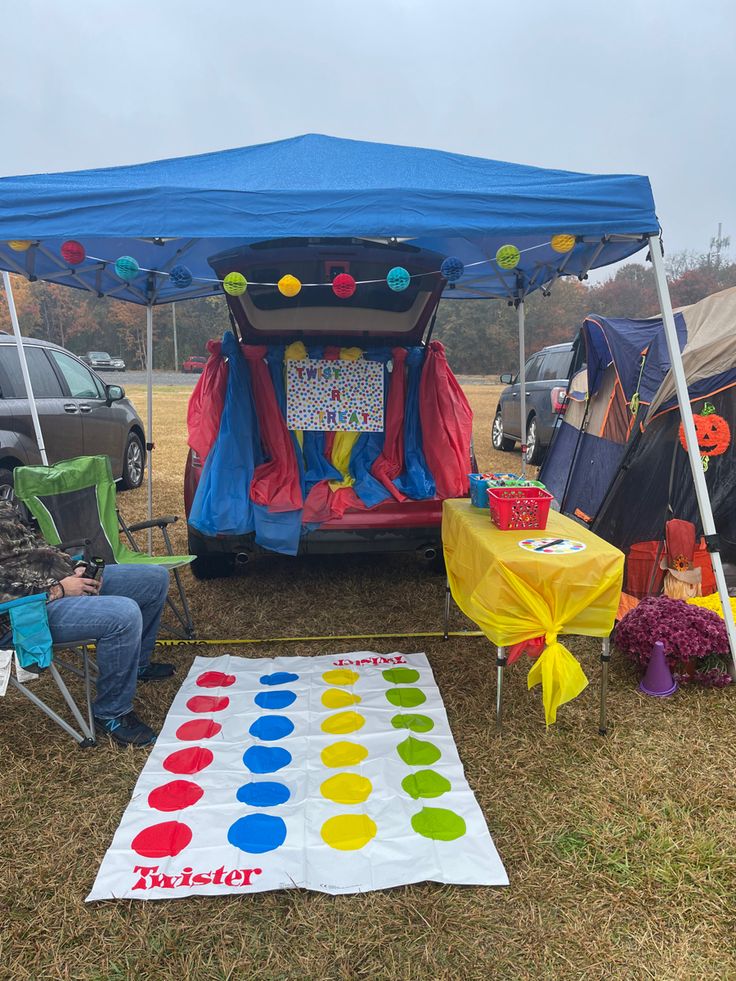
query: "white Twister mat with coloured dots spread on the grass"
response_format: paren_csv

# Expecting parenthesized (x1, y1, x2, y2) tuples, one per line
(87, 652, 508, 900)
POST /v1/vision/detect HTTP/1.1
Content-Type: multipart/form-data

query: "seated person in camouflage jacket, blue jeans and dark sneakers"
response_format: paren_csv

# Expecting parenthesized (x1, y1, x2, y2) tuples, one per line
(0, 501, 175, 746)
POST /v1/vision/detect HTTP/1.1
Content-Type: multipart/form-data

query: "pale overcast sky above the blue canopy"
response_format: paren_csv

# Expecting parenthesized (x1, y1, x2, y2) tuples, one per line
(0, 0, 736, 276)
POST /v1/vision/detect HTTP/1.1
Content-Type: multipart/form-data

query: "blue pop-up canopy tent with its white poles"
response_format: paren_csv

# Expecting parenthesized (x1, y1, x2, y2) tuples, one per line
(0, 135, 736, 668)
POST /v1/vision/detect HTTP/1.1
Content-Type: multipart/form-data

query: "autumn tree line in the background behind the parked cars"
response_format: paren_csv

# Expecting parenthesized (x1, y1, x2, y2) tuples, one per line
(0, 252, 736, 375)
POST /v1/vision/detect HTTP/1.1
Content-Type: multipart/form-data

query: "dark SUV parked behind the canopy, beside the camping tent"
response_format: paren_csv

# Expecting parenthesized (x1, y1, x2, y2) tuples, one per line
(491, 343, 574, 467)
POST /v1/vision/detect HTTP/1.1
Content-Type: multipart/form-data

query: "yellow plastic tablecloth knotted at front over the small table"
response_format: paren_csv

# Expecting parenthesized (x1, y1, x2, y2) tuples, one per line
(442, 500, 624, 725)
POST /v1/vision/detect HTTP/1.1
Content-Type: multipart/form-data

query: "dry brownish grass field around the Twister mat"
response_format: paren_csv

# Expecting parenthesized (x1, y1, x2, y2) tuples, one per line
(0, 384, 736, 981)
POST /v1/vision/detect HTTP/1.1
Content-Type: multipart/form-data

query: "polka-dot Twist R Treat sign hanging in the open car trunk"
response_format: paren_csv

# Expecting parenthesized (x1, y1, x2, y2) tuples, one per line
(286, 358, 383, 433)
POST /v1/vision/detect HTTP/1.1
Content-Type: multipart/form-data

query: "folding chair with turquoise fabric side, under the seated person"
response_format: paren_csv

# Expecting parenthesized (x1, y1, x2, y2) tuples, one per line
(0, 593, 97, 749)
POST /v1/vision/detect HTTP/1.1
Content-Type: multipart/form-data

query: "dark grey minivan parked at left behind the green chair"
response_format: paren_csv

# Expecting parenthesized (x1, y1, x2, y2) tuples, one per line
(0, 335, 146, 489)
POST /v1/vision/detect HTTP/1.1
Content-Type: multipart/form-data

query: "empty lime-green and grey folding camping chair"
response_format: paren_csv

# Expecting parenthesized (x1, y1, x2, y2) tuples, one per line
(13, 456, 194, 639)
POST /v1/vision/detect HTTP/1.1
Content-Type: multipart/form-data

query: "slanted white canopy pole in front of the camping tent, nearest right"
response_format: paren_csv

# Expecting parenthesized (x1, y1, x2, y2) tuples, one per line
(649, 235, 736, 678)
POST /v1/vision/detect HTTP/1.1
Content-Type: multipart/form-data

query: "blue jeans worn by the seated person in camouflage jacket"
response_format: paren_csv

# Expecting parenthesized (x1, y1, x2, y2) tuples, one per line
(46, 565, 169, 719)
